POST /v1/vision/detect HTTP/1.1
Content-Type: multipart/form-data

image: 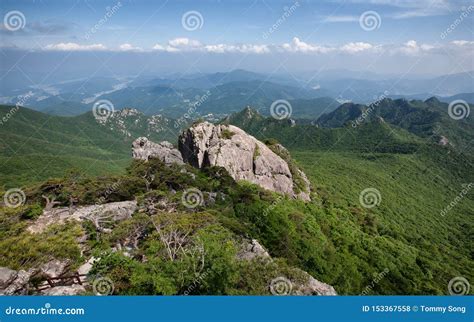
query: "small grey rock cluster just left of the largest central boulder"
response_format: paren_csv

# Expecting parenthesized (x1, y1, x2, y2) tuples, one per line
(132, 137, 183, 164)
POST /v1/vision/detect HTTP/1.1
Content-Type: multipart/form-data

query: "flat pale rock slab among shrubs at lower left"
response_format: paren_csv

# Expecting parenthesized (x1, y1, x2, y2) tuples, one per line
(27, 201, 137, 233)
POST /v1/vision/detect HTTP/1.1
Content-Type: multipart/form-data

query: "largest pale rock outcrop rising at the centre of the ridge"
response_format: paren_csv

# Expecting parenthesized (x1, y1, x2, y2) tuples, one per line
(178, 122, 309, 200)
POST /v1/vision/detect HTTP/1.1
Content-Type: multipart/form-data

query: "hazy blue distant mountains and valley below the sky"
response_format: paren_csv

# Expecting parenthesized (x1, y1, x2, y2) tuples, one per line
(1, 70, 474, 120)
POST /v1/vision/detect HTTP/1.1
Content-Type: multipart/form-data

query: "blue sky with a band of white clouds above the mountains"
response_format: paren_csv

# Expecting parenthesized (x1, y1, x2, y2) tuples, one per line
(0, 0, 474, 77)
